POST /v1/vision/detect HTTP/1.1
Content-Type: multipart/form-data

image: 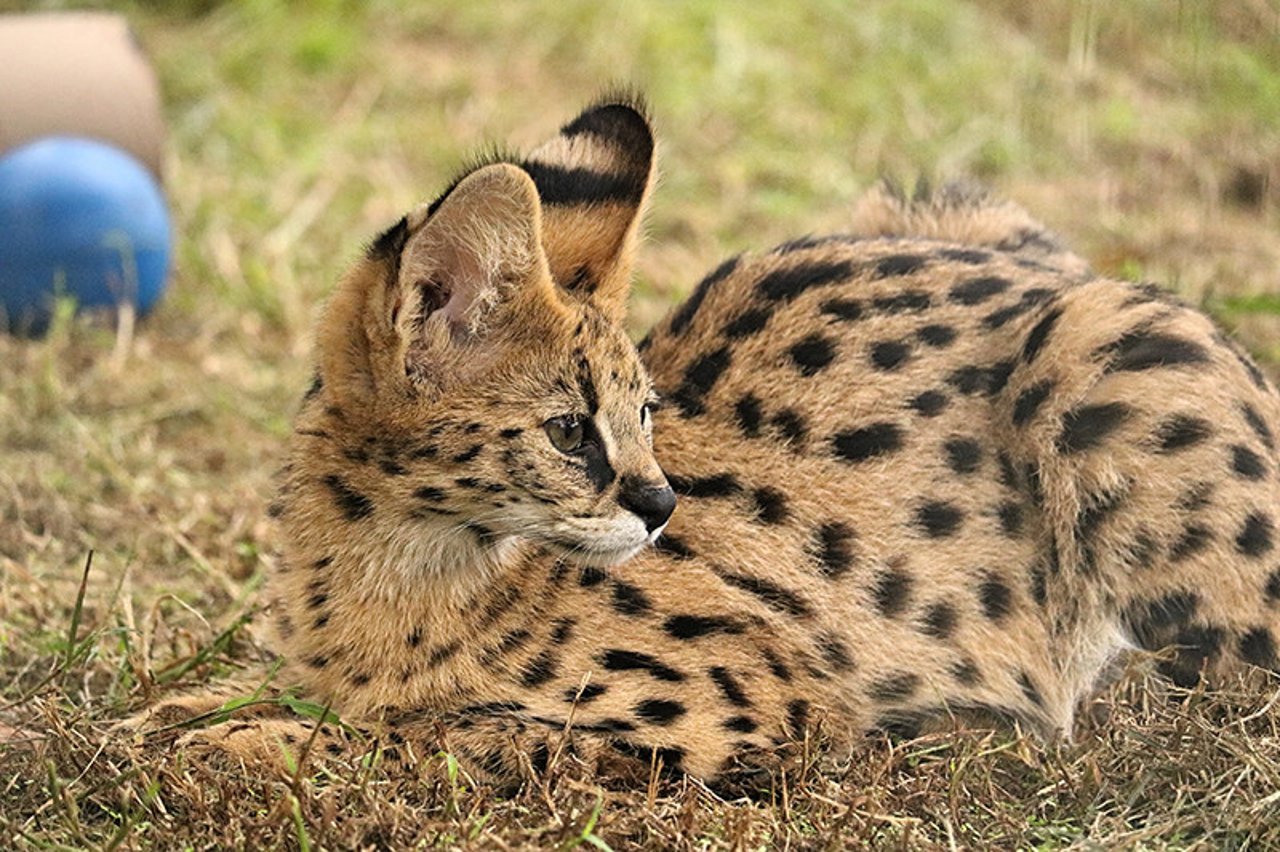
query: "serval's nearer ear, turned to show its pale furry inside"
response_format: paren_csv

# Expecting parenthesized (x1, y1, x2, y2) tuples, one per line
(319, 162, 563, 403)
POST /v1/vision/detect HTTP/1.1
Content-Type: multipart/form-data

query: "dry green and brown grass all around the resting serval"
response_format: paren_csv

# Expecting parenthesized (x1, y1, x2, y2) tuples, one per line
(0, 0, 1280, 849)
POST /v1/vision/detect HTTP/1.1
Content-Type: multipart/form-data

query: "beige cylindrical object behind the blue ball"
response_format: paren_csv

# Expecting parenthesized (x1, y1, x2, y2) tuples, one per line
(0, 12, 165, 178)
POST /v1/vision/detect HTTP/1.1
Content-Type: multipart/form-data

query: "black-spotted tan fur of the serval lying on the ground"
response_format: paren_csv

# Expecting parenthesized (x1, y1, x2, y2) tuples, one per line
(127, 97, 1280, 778)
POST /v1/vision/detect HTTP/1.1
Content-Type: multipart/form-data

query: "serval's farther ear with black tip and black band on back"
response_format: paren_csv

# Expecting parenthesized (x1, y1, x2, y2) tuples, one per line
(521, 99, 654, 321)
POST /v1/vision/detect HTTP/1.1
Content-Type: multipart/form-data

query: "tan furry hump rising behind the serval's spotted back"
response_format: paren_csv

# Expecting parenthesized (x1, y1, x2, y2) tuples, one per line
(854, 180, 1092, 280)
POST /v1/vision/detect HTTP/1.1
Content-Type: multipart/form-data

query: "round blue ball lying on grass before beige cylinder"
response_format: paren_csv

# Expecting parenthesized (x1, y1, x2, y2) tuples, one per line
(0, 137, 170, 335)
